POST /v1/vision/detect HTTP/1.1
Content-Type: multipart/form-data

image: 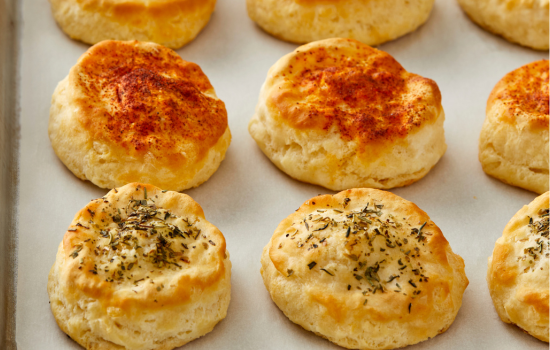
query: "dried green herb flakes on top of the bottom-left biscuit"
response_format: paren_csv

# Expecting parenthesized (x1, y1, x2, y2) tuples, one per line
(69, 187, 220, 288)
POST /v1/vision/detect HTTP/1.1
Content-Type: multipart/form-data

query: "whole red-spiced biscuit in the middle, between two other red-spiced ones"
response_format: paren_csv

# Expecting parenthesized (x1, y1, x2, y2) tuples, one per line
(248, 39, 447, 191)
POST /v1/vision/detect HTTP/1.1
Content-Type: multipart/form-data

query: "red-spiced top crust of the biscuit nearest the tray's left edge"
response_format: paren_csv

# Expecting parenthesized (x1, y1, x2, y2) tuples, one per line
(69, 41, 227, 167)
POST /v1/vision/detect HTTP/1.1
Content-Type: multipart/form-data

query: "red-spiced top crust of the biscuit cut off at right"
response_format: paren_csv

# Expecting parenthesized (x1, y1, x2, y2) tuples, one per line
(487, 60, 549, 129)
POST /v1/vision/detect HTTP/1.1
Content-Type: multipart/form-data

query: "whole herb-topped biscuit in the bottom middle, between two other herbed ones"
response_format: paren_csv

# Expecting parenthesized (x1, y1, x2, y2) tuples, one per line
(261, 189, 468, 349)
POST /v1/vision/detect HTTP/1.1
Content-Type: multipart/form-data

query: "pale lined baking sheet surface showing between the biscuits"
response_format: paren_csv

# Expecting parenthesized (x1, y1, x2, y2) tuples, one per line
(11, 0, 548, 350)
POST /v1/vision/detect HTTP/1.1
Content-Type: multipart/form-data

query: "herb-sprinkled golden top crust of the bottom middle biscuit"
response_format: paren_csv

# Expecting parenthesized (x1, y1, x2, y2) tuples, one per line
(269, 189, 468, 321)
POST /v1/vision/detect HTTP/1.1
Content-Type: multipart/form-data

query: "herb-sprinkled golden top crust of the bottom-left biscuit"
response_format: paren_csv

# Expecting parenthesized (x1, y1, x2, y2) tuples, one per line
(61, 183, 228, 310)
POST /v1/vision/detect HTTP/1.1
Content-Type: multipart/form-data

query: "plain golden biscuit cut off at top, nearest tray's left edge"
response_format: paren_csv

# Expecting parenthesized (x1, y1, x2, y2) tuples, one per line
(50, 0, 216, 49)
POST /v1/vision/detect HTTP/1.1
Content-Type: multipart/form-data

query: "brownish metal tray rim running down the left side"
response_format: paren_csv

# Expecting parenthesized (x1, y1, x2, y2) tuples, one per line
(0, 0, 21, 350)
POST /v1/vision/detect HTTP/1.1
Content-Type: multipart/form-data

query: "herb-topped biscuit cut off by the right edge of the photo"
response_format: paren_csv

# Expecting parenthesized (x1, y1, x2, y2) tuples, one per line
(487, 192, 550, 342)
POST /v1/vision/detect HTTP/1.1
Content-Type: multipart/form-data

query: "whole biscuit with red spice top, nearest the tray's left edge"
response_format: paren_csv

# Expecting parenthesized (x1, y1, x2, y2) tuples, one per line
(48, 41, 231, 191)
